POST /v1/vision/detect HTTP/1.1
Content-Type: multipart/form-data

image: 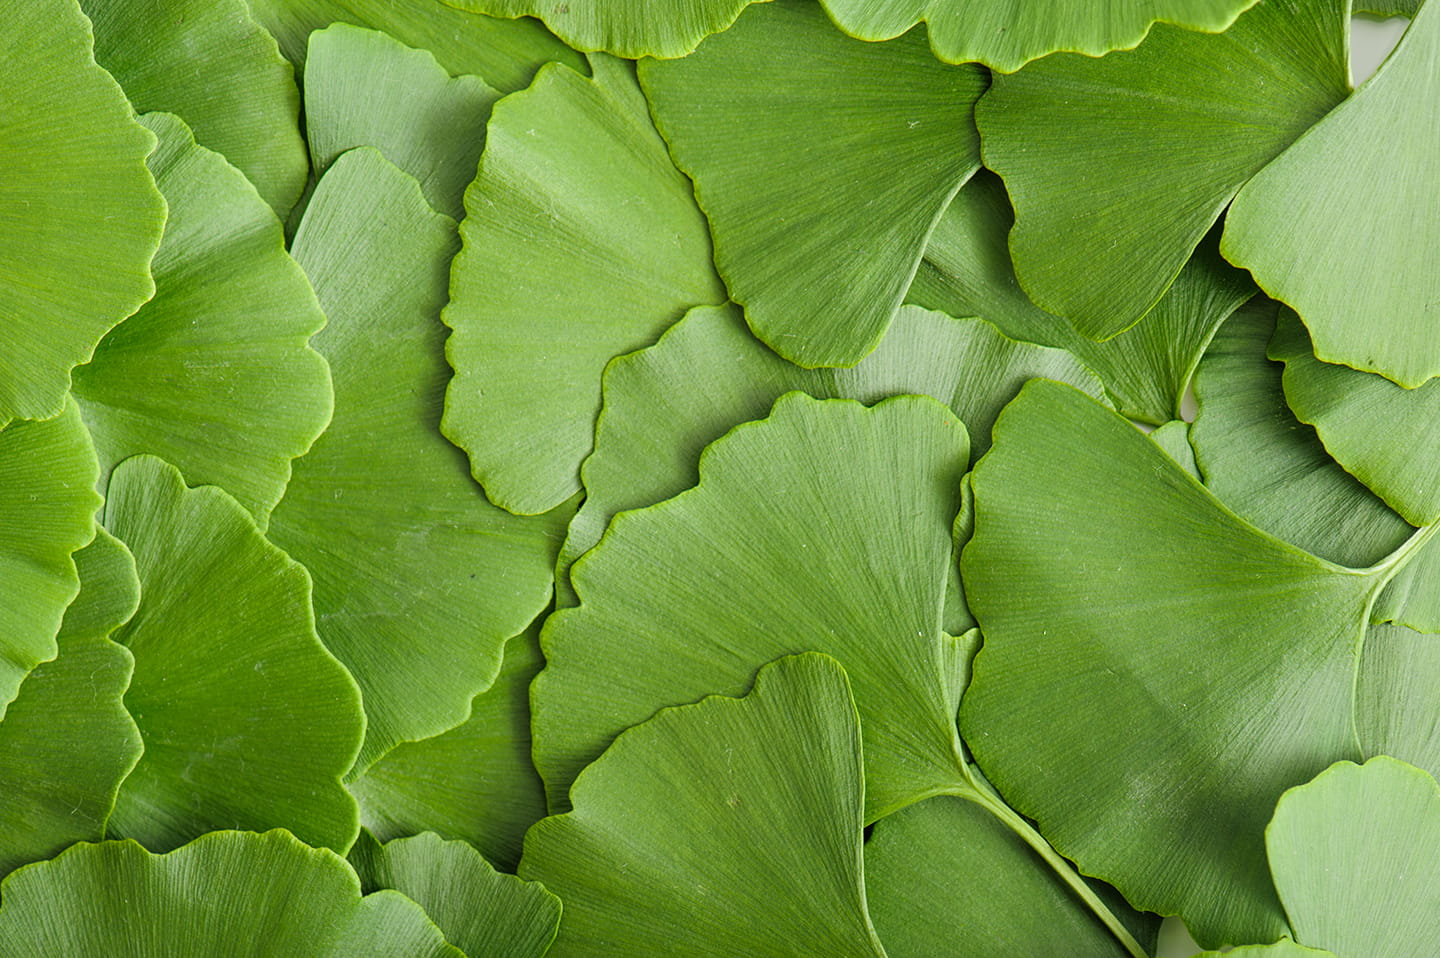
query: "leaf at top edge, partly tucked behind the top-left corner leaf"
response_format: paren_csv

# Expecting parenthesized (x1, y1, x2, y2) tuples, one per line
(81, 0, 310, 216)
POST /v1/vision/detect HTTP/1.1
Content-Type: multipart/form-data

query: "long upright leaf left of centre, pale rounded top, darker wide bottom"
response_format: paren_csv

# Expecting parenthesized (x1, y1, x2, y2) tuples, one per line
(269, 153, 566, 771)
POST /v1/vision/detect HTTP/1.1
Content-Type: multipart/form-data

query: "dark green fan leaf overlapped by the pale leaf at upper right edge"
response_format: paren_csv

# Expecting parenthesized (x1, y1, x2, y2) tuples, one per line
(975, 0, 1349, 340)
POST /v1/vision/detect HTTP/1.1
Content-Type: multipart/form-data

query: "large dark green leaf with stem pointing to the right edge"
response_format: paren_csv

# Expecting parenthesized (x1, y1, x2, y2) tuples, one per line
(960, 382, 1430, 946)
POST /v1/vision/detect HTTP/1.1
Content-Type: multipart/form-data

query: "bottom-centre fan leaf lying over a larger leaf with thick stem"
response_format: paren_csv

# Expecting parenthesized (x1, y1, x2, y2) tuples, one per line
(520, 654, 886, 958)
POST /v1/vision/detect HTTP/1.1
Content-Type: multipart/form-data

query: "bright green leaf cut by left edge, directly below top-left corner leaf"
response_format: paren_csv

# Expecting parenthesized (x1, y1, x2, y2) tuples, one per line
(0, 402, 101, 717)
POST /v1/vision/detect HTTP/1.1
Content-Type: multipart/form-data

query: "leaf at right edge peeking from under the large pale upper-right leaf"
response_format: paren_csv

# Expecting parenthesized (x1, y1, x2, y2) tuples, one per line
(1270, 310, 1440, 526)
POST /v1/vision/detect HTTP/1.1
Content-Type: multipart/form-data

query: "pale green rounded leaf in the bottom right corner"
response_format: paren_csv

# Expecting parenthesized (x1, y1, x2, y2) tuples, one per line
(1266, 756, 1440, 958)
